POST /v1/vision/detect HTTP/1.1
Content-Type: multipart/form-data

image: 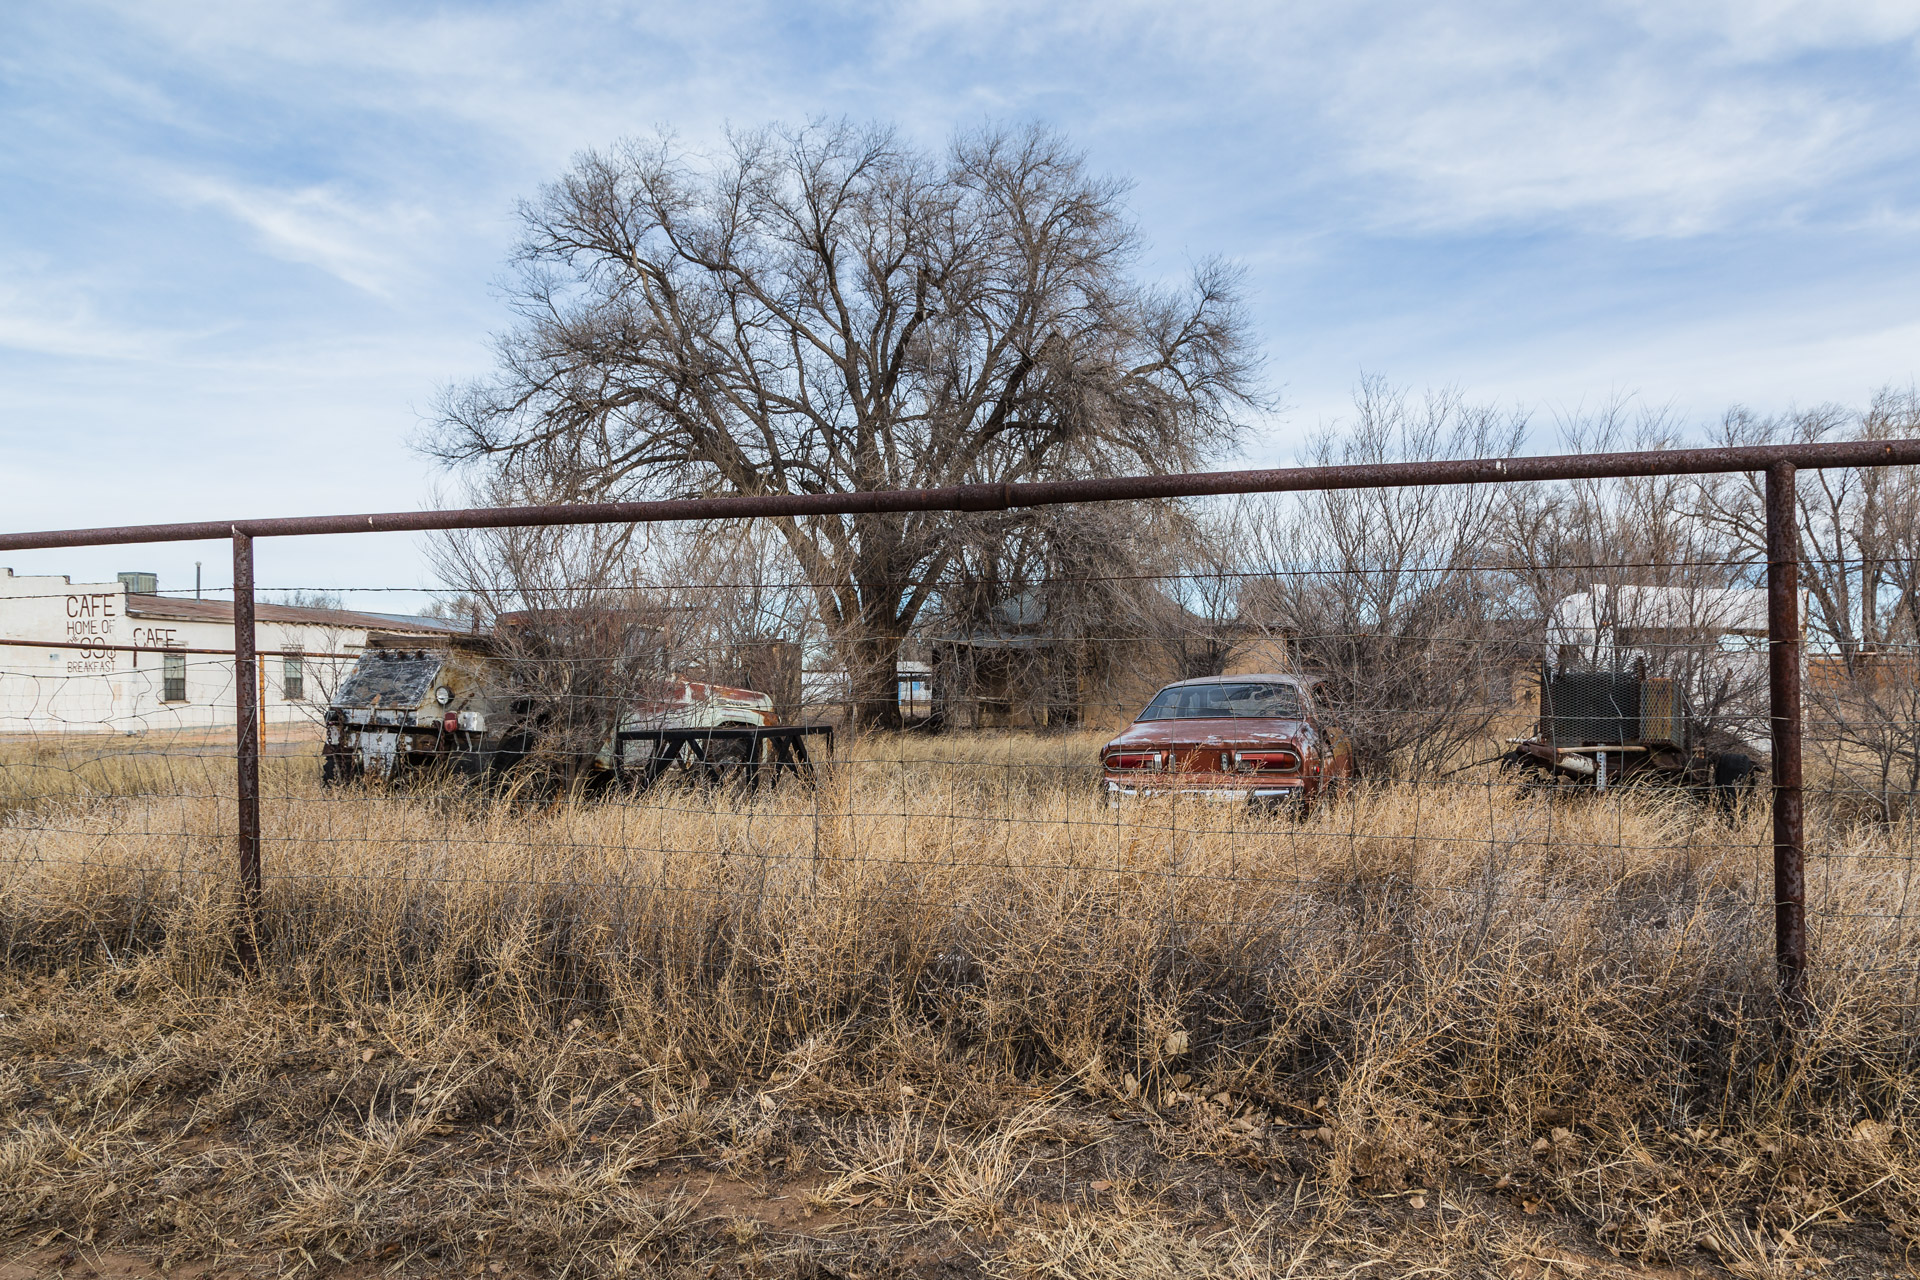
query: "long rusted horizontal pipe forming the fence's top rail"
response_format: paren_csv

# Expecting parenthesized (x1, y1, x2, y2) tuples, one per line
(0, 439, 1920, 551)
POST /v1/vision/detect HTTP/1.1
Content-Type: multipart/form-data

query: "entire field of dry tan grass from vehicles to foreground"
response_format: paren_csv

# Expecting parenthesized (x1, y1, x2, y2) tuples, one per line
(0, 735, 1920, 1276)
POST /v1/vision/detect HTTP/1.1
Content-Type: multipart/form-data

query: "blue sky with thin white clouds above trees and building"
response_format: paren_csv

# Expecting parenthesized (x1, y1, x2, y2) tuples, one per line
(0, 0, 1920, 604)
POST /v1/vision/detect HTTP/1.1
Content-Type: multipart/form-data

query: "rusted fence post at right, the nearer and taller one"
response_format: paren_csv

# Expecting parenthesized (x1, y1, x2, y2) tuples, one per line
(1766, 462, 1807, 1023)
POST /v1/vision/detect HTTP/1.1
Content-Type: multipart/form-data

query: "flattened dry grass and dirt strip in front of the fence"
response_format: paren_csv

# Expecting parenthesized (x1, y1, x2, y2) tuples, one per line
(0, 992, 1920, 1280)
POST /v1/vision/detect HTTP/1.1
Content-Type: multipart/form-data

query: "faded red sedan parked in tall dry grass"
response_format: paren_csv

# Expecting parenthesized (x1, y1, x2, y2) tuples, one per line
(1100, 676, 1354, 806)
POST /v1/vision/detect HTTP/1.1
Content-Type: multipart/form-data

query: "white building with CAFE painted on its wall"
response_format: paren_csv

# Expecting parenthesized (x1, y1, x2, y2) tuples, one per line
(0, 568, 453, 733)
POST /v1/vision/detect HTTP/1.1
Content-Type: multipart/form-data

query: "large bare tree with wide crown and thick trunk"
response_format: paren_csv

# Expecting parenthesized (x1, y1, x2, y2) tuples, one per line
(424, 123, 1256, 725)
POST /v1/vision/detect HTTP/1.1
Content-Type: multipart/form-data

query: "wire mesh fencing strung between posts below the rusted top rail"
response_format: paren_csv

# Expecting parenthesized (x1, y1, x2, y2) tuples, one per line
(0, 452, 1920, 1034)
